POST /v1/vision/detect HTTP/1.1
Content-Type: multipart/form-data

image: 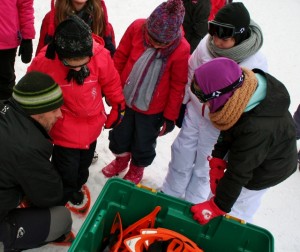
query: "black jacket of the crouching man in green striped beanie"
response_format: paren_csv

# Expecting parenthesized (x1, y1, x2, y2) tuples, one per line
(0, 100, 63, 221)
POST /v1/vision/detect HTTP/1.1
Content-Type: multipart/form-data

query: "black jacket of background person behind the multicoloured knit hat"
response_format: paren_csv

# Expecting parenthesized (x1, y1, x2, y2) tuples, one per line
(182, 0, 211, 53)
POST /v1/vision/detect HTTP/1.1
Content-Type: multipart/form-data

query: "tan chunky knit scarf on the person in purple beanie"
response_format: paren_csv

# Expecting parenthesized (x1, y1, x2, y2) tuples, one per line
(209, 67, 257, 130)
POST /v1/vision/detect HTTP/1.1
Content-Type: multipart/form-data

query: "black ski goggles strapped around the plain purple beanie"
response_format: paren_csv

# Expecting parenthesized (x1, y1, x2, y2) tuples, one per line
(191, 74, 245, 103)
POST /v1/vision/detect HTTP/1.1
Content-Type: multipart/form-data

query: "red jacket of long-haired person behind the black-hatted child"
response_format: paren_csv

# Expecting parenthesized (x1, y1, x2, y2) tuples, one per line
(36, 0, 116, 55)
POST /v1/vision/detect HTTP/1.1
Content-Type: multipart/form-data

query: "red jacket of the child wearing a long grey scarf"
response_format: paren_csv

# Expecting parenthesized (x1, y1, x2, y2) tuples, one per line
(113, 19, 190, 120)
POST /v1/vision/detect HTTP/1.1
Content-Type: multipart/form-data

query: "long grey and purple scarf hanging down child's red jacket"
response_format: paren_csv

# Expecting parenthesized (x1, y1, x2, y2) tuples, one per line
(123, 29, 182, 111)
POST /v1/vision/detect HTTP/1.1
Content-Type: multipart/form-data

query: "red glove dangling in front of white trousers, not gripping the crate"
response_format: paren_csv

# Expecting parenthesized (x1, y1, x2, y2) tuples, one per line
(208, 157, 227, 195)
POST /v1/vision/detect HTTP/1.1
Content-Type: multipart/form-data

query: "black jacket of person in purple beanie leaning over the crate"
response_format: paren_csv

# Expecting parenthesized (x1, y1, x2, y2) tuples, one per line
(212, 70, 297, 212)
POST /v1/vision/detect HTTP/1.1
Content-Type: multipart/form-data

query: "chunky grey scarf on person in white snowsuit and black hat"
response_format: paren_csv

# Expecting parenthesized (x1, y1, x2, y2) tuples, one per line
(207, 20, 263, 63)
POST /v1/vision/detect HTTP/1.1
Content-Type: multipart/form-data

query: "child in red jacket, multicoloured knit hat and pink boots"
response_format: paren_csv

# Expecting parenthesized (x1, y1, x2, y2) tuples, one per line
(102, 0, 190, 184)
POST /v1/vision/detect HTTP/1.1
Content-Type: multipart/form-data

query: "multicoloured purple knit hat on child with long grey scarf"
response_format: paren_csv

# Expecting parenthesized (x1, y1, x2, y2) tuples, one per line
(146, 0, 184, 44)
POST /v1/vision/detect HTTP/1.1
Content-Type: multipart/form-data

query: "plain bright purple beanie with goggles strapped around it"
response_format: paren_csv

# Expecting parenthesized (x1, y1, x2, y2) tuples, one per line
(194, 57, 242, 113)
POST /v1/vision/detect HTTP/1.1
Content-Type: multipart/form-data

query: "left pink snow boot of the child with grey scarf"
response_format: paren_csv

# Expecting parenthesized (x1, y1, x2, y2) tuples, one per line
(102, 152, 130, 178)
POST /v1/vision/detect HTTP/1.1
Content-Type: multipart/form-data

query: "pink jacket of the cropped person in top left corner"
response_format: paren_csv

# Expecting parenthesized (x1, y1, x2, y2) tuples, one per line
(0, 0, 35, 50)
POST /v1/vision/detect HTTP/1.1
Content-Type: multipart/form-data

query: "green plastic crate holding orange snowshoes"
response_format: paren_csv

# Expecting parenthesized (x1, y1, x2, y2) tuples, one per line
(69, 178, 274, 252)
